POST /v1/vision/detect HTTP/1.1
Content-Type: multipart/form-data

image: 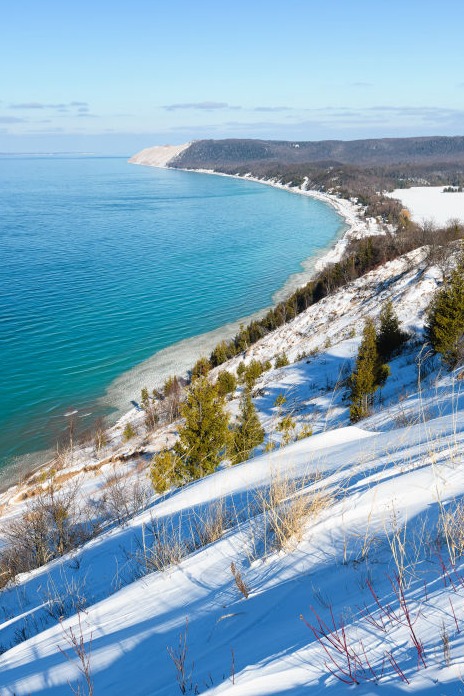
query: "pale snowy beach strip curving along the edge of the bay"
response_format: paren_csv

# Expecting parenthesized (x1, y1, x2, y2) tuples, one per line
(0, 163, 379, 494)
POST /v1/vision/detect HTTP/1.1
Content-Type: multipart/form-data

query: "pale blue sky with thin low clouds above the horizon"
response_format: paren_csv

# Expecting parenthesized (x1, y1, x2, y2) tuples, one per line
(0, 0, 464, 155)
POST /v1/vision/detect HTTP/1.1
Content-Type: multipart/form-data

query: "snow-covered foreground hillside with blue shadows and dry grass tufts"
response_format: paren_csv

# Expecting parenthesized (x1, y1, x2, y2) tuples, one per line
(0, 227, 464, 696)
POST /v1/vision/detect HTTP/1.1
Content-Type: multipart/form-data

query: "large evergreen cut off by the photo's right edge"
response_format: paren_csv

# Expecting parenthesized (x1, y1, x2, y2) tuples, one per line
(426, 255, 464, 368)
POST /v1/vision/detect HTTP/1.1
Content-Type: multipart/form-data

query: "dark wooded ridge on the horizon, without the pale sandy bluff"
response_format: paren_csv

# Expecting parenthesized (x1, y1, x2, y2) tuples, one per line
(169, 136, 464, 171)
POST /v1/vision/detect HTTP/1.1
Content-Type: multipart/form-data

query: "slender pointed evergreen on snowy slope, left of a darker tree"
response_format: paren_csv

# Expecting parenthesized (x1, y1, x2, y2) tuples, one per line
(350, 317, 389, 423)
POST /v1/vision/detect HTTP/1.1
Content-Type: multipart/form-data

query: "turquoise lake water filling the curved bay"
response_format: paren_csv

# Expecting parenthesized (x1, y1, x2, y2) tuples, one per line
(0, 157, 343, 476)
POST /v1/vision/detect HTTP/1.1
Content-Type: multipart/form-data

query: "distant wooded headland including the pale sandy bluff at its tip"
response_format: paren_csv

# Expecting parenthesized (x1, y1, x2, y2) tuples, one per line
(129, 136, 464, 203)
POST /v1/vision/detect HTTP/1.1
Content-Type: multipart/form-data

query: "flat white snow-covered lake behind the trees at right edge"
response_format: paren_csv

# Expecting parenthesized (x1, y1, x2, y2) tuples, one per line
(385, 186, 464, 225)
